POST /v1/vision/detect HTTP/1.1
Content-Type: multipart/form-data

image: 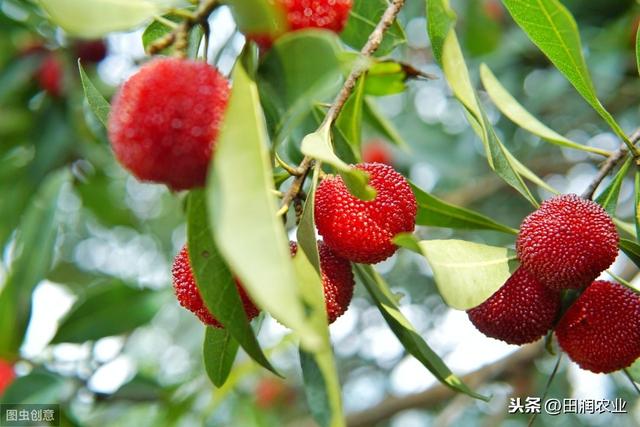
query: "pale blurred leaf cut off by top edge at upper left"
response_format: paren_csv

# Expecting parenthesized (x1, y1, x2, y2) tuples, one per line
(38, 0, 178, 38)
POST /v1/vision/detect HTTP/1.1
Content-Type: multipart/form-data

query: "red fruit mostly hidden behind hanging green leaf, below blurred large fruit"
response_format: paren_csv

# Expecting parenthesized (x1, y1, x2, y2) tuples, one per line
(172, 245, 260, 328)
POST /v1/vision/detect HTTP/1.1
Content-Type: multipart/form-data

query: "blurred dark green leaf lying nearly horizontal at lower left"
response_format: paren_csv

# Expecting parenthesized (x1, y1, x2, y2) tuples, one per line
(51, 281, 163, 344)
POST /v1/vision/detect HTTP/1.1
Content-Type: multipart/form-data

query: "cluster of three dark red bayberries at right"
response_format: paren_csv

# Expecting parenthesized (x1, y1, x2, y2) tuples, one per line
(468, 194, 640, 372)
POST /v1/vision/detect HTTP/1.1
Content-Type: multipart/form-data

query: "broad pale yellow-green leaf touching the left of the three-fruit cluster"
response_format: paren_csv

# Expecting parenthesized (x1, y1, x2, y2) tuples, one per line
(408, 240, 517, 310)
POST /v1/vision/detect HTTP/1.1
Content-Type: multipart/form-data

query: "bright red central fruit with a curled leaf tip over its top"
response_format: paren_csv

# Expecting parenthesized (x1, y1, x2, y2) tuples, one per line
(315, 163, 417, 264)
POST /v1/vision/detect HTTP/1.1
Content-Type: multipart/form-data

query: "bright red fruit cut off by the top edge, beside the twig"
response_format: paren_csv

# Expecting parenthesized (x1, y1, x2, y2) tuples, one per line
(248, 0, 353, 49)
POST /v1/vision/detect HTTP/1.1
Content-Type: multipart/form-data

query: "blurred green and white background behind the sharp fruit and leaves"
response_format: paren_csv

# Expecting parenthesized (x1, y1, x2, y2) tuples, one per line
(0, 0, 640, 427)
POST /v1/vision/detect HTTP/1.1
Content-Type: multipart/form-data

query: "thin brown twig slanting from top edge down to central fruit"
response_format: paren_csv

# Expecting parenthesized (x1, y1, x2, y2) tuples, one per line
(278, 0, 405, 215)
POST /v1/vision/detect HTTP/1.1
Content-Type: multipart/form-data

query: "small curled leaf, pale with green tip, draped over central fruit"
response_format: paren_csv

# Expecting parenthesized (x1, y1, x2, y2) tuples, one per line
(301, 123, 376, 200)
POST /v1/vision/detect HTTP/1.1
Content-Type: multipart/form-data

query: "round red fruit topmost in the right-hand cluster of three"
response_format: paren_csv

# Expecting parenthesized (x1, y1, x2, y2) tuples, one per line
(516, 194, 618, 289)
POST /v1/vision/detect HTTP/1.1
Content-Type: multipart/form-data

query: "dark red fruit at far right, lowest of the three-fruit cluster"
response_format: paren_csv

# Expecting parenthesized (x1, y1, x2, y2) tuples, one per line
(556, 280, 640, 373)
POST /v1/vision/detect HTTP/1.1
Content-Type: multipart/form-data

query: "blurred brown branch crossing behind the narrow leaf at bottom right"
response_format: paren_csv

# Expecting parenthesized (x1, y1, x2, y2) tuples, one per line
(347, 342, 543, 427)
